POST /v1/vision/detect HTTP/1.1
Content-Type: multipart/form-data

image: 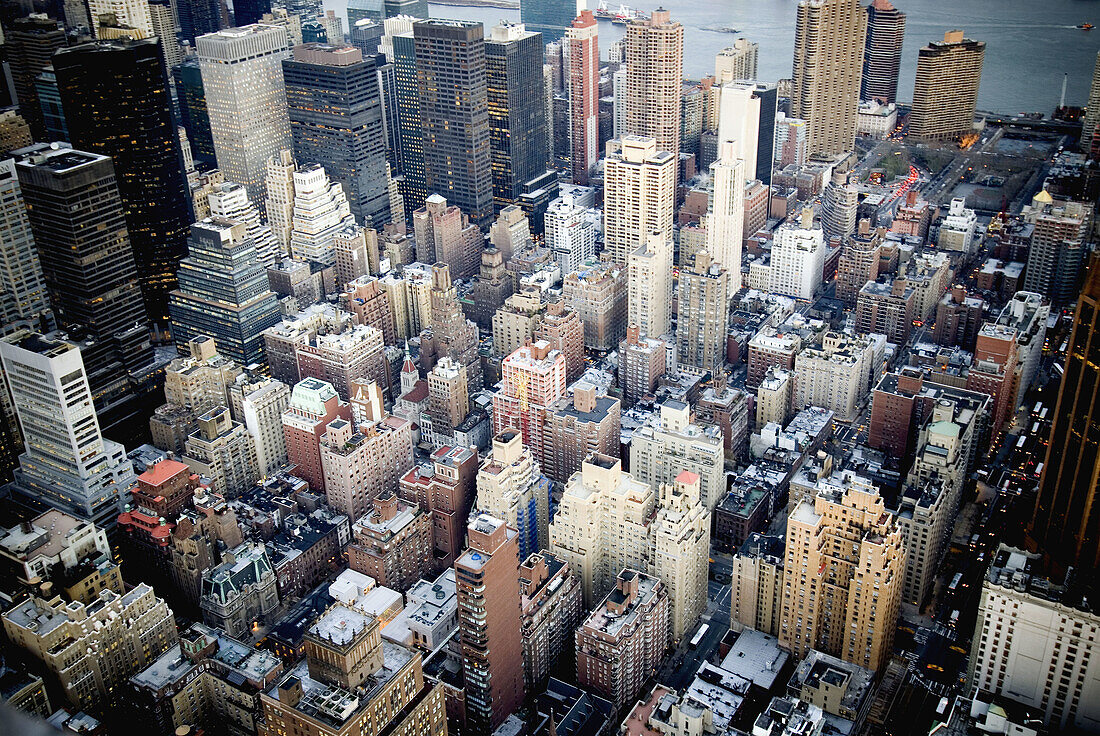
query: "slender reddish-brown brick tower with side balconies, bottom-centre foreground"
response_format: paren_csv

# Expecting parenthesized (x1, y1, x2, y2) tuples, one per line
(454, 514, 524, 733)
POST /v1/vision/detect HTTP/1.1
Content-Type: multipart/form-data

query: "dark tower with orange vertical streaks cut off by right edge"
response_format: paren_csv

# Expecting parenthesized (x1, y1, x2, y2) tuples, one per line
(1029, 257, 1100, 571)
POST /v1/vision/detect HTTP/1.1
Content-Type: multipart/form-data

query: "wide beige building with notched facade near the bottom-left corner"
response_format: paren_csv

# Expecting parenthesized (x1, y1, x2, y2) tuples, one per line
(3, 583, 176, 711)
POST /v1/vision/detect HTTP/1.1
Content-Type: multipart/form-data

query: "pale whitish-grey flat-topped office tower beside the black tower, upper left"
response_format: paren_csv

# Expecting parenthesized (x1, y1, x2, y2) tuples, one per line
(195, 25, 292, 207)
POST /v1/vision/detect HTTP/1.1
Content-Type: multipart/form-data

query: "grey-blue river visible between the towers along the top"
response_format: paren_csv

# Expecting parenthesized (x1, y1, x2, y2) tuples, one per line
(325, 0, 1100, 114)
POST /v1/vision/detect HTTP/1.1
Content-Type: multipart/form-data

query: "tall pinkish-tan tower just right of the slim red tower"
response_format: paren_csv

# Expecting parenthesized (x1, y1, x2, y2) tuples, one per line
(625, 8, 682, 161)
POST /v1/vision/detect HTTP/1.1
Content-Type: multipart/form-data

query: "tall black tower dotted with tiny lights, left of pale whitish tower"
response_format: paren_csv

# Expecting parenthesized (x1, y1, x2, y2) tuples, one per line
(53, 39, 191, 325)
